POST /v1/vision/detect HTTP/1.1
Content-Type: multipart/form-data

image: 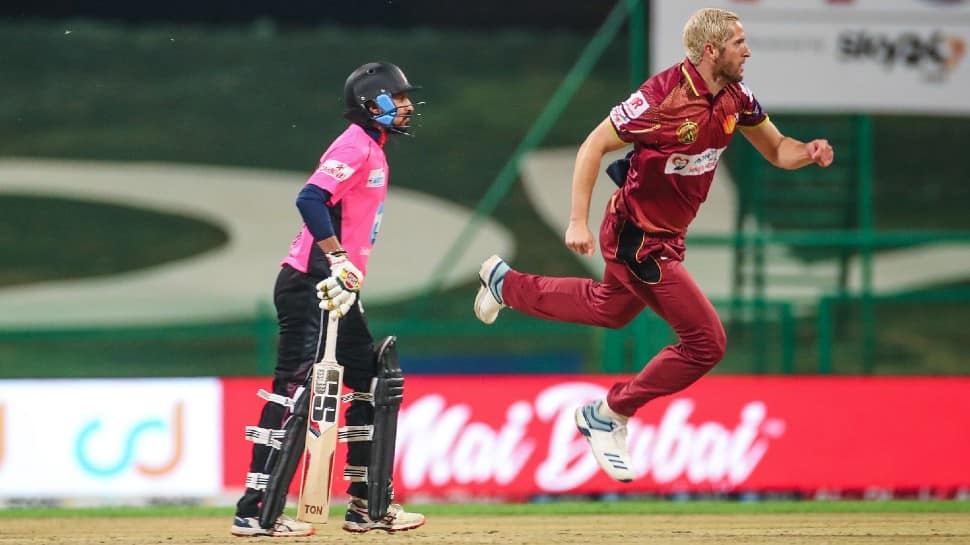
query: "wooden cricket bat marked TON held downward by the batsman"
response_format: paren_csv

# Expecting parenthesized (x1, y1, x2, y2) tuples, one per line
(297, 312, 344, 523)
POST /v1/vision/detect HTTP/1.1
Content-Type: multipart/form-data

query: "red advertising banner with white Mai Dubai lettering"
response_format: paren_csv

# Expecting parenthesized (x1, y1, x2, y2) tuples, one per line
(224, 375, 970, 498)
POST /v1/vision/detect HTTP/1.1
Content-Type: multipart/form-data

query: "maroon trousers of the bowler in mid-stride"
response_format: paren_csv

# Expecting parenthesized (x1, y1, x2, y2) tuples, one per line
(502, 198, 727, 416)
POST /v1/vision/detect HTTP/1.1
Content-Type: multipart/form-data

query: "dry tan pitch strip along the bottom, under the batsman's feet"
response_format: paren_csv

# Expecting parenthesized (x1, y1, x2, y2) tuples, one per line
(0, 513, 970, 545)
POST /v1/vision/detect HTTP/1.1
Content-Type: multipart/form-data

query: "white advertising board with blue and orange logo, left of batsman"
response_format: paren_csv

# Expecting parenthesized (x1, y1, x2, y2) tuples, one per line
(0, 378, 222, 498)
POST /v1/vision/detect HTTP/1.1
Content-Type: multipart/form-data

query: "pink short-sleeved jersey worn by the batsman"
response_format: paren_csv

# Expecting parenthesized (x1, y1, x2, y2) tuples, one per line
(283, 124, 388, 274)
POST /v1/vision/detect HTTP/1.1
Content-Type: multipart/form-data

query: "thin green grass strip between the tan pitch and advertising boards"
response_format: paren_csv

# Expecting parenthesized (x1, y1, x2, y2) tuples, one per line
(0, 500, 970, 519)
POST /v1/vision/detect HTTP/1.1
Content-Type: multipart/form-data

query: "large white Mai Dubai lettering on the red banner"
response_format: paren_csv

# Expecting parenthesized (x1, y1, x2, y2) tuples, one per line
(397, 382, 785, 492)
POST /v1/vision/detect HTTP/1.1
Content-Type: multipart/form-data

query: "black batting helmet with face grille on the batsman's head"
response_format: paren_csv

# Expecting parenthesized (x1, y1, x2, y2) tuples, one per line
(344, 62, 421, 126)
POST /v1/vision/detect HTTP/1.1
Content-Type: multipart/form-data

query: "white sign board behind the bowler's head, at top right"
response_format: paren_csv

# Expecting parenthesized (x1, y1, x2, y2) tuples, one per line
(650, 0, 970, 115)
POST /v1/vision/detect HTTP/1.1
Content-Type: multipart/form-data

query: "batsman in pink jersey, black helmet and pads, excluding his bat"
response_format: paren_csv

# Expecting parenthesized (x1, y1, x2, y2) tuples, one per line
(231, 62, 425, 537)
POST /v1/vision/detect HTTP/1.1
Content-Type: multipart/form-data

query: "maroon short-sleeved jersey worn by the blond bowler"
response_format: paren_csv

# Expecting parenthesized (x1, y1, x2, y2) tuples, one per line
(610, 59, 768, 235)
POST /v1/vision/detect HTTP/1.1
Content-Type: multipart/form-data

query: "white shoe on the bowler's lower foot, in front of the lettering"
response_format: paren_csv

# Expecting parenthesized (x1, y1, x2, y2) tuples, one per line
(576, 400, 635, 483)
